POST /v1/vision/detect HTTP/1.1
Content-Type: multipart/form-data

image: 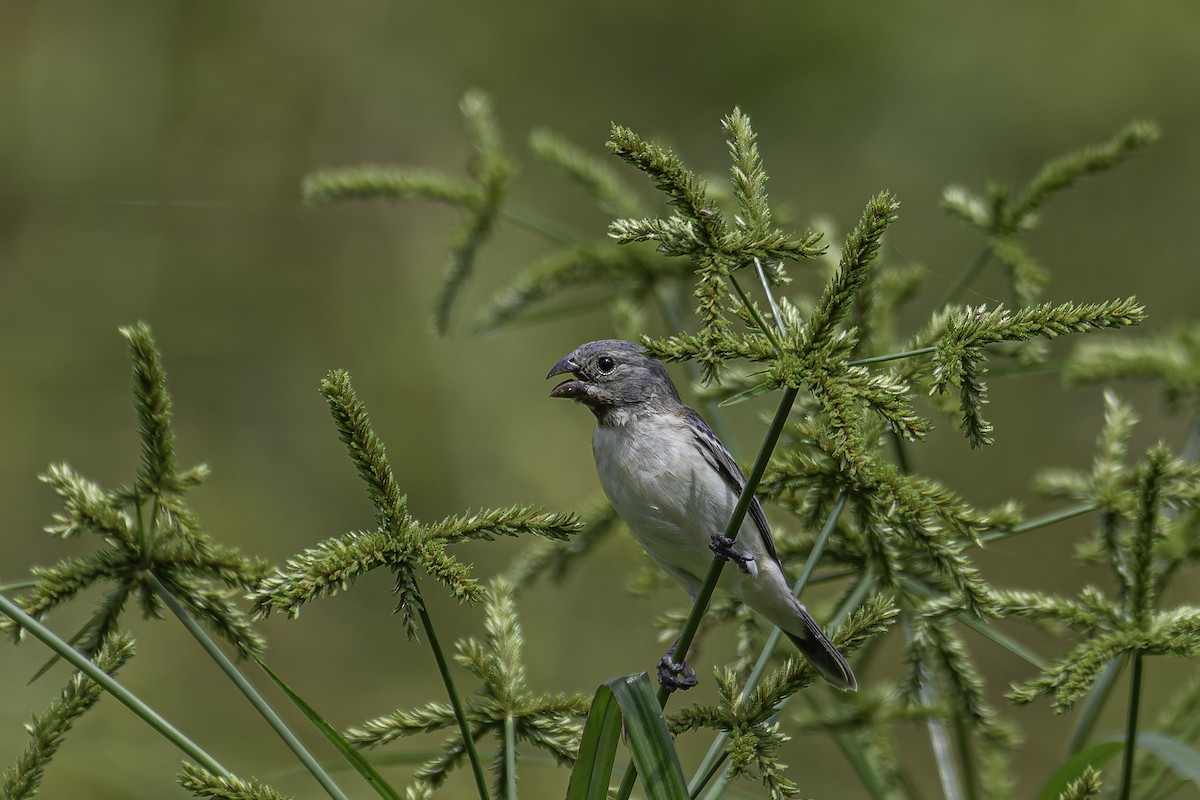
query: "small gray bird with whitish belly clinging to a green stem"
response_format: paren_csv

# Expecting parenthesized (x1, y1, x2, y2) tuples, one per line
(546, 339, 858, 691)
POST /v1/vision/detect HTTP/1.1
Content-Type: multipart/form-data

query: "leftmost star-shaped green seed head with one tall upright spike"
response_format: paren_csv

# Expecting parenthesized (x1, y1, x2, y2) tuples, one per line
(0, 323, 266, 656)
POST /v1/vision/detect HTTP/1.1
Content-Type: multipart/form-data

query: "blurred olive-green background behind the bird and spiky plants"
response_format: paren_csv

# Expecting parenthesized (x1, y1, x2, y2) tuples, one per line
(0, 0, 1200, 799)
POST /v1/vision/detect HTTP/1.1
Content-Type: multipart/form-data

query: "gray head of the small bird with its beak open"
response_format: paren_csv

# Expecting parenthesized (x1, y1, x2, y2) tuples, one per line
(546, 339, 680, 421)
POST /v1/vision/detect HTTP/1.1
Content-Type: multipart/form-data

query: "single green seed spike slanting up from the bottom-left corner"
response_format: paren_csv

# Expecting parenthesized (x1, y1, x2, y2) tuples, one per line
(0, 633, 133, 800)
